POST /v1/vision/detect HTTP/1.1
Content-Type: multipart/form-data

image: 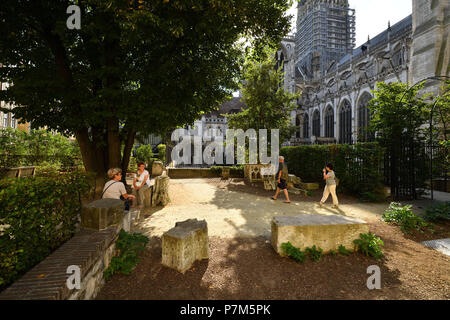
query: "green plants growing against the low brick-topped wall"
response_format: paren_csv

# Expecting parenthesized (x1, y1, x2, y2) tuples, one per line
(103, 229, 148, 281)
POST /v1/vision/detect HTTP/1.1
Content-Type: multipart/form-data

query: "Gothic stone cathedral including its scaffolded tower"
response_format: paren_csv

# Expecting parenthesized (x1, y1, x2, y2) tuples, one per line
(284, 0, 450, 146)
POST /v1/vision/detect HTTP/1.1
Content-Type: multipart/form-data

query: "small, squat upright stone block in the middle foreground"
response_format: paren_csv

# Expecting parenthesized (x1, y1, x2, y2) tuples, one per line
(162, 219, 209, 274)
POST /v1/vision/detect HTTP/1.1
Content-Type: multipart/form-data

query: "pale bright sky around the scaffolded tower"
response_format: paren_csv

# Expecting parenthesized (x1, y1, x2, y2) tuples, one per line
(288, 0, 412, 47)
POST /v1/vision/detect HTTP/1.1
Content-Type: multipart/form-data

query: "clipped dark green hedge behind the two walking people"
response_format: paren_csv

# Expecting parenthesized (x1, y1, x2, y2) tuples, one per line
(280, 143, 384, 200)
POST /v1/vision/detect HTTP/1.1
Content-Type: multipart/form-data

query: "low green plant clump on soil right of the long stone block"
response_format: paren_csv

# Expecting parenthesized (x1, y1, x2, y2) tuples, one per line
(382, 202, 432, 233)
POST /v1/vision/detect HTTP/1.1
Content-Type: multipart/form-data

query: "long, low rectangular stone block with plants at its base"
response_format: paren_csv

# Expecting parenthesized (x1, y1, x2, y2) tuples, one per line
(272, 214, 369, 257)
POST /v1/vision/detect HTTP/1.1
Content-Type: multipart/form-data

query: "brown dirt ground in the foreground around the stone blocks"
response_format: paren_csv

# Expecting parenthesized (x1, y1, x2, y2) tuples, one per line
(97, 222, 450, 300)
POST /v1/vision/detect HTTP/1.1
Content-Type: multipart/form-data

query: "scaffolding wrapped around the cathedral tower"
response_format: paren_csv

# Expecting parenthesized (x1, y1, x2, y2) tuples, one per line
(295, 0, 356, 80)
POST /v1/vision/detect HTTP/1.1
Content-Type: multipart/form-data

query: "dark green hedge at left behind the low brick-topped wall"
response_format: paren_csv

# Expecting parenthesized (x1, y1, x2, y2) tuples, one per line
(0, 172, 90, 290)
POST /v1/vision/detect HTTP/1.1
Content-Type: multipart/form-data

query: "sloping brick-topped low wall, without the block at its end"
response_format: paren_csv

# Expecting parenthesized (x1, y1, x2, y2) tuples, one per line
(0, 215, 123, 300)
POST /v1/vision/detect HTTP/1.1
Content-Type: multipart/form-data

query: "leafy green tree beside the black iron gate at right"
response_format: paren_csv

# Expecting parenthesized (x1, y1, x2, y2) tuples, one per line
(369, 82, 430, 198)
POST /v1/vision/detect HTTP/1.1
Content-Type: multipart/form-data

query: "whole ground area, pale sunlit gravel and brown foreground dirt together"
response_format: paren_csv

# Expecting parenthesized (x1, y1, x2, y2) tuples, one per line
(97, 179, 450, 300)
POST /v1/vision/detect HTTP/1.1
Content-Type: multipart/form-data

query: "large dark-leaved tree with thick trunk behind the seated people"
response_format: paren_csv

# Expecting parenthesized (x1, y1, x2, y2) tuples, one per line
(0, 0, 291, 175)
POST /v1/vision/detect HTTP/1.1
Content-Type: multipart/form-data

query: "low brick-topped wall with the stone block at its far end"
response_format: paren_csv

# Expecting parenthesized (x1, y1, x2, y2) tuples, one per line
(0, 199, 131, 300)
